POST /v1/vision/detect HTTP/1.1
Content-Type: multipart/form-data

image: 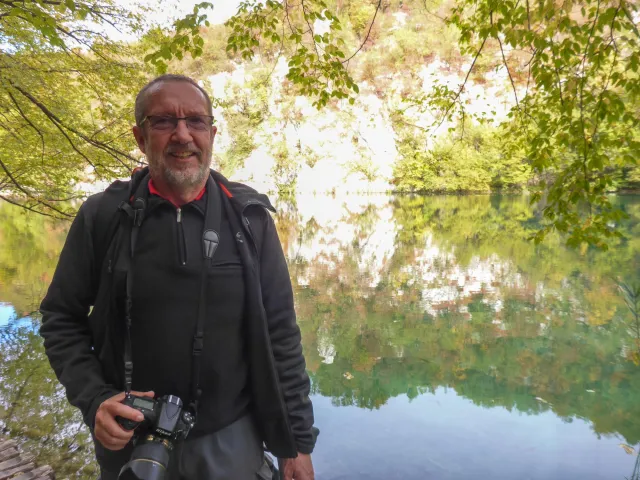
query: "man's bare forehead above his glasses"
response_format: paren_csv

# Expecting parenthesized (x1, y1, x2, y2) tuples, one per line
(145, 82, 211, 115)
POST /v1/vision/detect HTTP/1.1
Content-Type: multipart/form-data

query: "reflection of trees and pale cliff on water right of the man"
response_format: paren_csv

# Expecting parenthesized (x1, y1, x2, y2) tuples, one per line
(288, 193, 640, 444)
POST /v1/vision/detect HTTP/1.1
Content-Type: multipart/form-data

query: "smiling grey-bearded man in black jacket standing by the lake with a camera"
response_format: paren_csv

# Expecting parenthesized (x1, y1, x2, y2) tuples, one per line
(40, 75, 317, 480)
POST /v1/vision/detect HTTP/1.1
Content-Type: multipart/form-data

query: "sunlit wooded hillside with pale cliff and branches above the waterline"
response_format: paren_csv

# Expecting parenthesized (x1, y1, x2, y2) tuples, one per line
(0, 0, 640, 244)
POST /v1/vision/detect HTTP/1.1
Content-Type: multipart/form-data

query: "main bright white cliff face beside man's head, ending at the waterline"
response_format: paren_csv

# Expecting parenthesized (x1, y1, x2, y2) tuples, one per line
(205, 60, 397, 193)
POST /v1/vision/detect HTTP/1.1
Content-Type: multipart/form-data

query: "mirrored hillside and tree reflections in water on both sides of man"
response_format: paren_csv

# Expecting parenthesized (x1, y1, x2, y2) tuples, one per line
(0, 196, 640, 476)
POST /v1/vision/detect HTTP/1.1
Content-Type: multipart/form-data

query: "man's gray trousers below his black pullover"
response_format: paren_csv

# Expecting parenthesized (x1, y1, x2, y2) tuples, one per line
(100, 415, 272, 480)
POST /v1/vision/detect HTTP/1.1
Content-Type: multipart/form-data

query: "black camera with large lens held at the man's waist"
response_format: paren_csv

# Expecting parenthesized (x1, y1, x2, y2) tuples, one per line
(116, 394, 195, 480)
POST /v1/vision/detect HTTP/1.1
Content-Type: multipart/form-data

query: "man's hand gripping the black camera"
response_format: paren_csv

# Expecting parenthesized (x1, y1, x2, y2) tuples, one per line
(94, 392, 153, 450)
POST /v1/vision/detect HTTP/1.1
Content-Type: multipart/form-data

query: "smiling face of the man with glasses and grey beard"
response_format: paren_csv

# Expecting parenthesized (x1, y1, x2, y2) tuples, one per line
(133, 82, 216, 191)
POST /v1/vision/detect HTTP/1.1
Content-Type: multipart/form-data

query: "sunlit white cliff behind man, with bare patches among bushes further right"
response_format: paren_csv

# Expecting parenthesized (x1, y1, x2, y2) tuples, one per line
(203, 49, 512, 197)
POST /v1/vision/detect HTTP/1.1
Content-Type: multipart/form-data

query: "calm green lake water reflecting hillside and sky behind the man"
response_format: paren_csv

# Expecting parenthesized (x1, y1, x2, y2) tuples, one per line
(0, 196, 640, 480)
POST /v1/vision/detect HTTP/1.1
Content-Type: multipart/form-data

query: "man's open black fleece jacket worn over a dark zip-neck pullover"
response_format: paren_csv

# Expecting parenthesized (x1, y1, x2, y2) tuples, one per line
(40, 169, 317, 464)
